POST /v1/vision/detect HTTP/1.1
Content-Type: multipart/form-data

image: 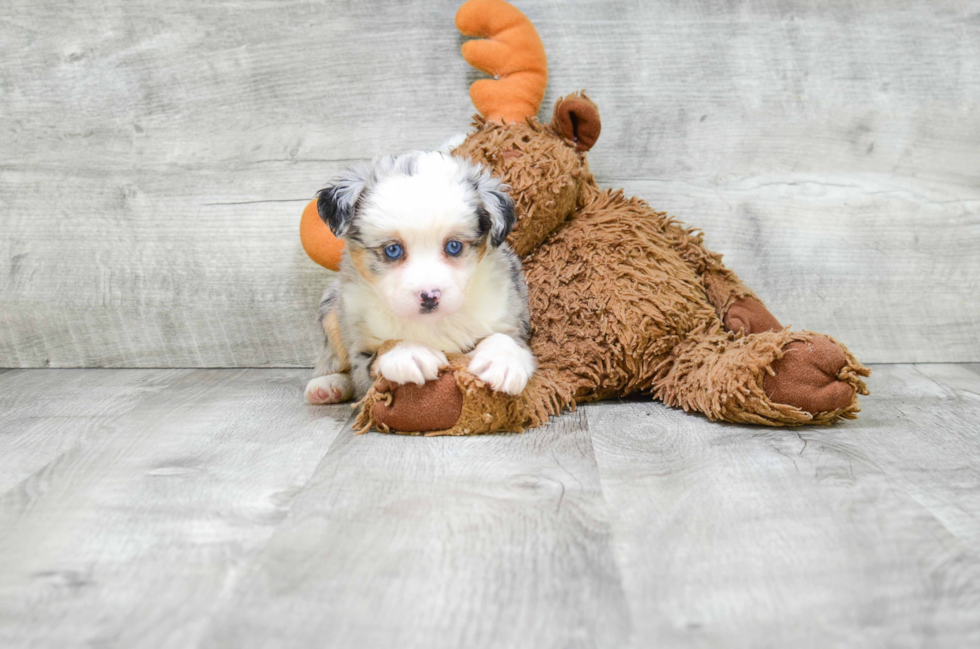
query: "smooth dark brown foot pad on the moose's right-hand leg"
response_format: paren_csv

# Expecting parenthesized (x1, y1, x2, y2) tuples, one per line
(764, 336, 855, 414)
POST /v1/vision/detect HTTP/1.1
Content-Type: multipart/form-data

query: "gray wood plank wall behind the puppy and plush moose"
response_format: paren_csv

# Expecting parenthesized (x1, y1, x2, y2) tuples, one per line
(0, 0, 980, 367)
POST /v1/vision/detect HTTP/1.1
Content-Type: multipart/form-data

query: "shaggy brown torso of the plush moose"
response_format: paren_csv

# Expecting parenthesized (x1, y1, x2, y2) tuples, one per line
(524, 189, 721, 401)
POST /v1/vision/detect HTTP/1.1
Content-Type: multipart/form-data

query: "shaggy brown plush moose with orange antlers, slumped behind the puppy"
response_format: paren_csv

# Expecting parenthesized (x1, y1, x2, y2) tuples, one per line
(303, 0, 870, 435)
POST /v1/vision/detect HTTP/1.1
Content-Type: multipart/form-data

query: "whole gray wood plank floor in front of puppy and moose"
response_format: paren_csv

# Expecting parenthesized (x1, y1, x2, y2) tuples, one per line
(0, 364, 980, 649)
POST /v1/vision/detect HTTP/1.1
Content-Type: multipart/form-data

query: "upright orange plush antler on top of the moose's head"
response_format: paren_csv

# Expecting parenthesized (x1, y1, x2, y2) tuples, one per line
(456, 0, 548, 122)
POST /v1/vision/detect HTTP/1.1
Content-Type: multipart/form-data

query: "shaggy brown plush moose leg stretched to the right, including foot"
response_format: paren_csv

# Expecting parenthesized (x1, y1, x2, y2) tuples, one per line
(654, 330, 870, 426)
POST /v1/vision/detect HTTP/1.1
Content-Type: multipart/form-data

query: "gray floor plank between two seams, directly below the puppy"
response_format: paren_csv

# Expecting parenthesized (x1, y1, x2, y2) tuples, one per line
(205, 413, 630, 649)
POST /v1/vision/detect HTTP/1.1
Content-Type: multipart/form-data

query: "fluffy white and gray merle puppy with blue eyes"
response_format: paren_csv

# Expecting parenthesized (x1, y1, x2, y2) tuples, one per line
(306, 152, 535, 404)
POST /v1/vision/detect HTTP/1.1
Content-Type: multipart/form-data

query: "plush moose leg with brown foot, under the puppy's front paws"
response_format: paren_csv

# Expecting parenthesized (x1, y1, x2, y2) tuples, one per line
(354, 354, 572, 436)
